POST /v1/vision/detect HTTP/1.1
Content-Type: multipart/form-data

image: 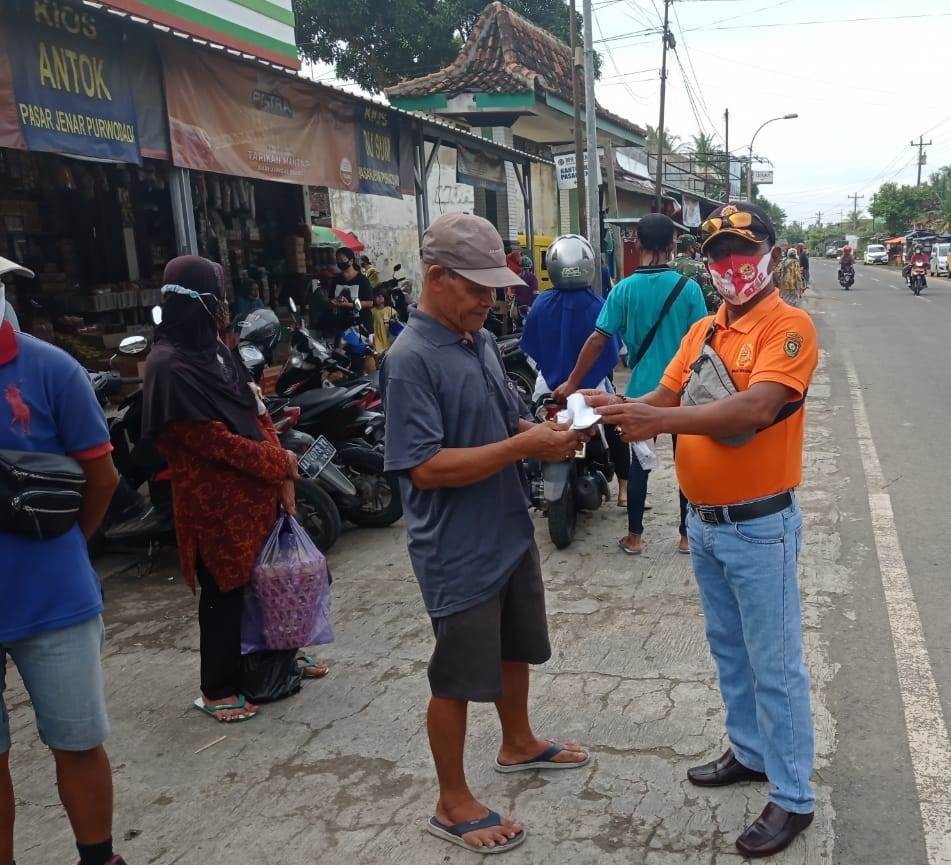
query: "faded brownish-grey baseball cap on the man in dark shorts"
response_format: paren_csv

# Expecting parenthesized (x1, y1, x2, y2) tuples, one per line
(419, 213, 525, 288)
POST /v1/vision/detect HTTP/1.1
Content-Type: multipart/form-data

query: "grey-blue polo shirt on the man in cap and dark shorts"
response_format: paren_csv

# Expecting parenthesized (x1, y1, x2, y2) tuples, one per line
(380, 309, 535, 618)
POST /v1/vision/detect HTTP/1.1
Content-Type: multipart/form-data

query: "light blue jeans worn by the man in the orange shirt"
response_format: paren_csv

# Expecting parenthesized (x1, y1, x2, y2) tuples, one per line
(687, 501, 815, 814)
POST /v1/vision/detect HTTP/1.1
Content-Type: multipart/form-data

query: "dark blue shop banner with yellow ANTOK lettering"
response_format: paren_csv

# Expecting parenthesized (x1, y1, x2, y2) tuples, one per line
(6, 0, 142, 163)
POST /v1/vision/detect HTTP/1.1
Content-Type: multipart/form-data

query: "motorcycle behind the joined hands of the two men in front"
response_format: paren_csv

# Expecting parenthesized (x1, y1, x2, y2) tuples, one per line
(526, 394, 614, 550)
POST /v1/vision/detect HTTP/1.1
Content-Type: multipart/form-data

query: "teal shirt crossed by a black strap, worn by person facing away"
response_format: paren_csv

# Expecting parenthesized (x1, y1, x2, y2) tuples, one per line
(596, 265, 708, 397)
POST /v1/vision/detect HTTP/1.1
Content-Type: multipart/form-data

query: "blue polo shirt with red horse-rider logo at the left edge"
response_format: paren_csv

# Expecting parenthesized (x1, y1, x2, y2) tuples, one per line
(0, 322, 112, 645)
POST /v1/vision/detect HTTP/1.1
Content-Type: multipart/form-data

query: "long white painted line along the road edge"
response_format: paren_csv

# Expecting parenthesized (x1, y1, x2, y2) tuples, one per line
(845, 355, 951, 865)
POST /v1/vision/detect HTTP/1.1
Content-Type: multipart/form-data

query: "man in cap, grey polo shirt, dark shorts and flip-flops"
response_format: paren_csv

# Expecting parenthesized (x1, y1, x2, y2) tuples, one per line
(381, 214, 590, 852)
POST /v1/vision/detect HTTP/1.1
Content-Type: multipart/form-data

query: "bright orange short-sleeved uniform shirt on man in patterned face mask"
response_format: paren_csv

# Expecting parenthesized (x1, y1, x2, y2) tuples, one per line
(661, 294, 819, 505)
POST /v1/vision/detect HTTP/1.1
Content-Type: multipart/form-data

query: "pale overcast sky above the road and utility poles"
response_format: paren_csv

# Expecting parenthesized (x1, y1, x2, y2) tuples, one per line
(592, 0, 951, 224)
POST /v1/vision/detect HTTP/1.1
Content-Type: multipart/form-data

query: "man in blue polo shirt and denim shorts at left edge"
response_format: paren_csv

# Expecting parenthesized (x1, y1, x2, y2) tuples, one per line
(0, 258, 123, 865)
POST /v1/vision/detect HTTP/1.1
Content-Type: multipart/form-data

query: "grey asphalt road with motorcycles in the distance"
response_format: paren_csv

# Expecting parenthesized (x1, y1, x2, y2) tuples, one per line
(807, 261, 951, 865)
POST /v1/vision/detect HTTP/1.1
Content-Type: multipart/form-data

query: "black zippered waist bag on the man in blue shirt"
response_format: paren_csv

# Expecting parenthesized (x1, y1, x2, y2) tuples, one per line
(0, 450, 86, 540)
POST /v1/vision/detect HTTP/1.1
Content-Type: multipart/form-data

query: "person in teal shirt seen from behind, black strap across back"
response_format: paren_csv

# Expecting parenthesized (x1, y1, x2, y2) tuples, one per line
(553, 213, 707, 556)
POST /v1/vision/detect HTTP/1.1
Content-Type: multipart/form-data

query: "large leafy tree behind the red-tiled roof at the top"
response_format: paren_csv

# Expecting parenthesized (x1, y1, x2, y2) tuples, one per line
(294, 0, 601, 93)
